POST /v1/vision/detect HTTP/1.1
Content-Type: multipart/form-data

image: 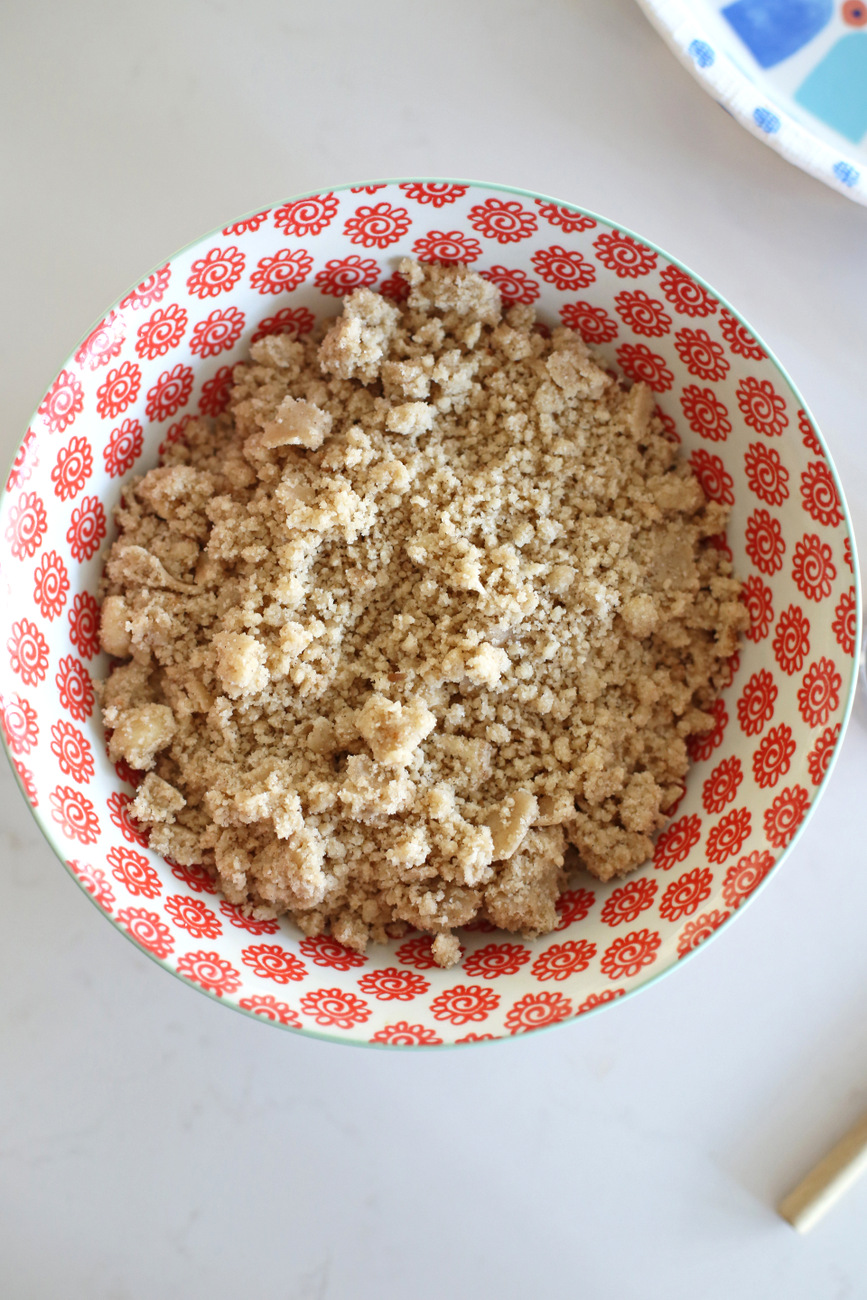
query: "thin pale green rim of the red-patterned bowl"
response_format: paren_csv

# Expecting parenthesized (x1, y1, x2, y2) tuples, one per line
(0, 175, 863, 1053)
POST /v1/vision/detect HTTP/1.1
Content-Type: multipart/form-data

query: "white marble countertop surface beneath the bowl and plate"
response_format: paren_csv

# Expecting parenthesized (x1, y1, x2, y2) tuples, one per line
(0, 0, 867, 1300)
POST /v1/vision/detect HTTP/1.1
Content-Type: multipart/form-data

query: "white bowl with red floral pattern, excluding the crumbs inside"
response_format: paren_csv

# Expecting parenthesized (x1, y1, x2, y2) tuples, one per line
(0, 181, 861, 1045)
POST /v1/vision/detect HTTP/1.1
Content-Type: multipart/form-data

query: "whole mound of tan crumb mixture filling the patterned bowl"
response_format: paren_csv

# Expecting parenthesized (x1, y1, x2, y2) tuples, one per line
(101, 263, 746, 965)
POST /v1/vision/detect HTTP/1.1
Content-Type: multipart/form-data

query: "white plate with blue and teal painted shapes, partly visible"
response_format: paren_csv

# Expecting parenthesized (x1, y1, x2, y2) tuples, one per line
(638, 0, 867, 203)
